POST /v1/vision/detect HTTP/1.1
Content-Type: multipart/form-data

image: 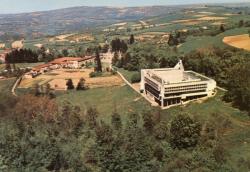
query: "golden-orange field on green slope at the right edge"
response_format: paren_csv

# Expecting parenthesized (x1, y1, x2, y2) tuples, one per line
(223, 34, 250, 51)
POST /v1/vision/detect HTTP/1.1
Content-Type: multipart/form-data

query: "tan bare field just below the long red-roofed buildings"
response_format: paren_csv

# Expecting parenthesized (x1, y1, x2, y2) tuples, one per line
(19, 69, 123, 90)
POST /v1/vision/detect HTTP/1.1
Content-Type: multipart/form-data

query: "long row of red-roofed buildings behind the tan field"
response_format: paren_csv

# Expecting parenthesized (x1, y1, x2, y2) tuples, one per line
(25, 56, 94, 78)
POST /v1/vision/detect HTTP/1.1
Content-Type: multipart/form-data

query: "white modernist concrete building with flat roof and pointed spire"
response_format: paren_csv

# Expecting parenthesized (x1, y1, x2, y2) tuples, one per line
(140, 60, 216, 108)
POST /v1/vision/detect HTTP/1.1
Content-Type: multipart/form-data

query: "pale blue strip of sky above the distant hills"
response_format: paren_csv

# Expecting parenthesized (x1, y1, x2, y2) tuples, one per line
(0, 0, 250, 14)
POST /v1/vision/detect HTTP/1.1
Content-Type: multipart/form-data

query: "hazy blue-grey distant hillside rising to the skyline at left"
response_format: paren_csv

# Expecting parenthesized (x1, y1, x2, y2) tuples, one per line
(0, 6, 200, 40)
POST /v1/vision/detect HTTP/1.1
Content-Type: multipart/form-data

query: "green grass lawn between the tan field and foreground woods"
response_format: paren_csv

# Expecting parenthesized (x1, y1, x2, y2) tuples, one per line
(57, 86, 154, 119)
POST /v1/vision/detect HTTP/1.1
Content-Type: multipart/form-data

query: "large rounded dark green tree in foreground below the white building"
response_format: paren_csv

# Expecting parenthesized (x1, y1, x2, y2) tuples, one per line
(170, 114, 201, 149)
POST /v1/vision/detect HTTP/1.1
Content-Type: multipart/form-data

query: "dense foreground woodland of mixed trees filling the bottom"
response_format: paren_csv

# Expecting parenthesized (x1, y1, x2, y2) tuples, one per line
(0, 92, 240, 172)
